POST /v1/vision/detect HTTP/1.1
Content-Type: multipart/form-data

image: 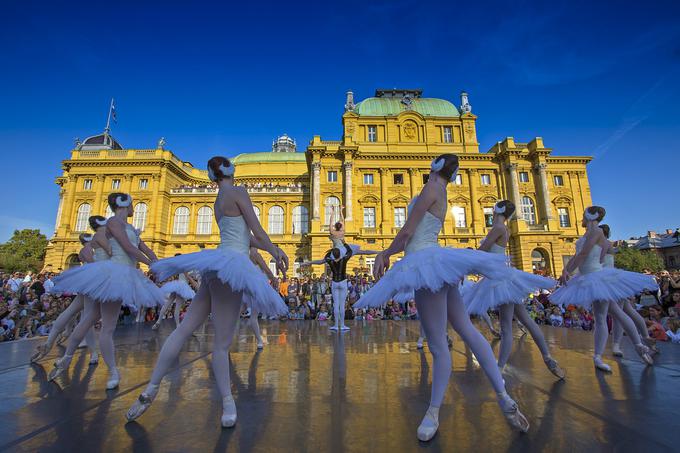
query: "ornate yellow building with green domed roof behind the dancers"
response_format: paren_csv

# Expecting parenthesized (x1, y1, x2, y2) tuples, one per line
(46, 90, 591, 275)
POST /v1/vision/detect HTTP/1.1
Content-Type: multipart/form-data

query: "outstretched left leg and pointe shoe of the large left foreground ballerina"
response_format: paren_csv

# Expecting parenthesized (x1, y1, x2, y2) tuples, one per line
(127, 282, 210, 421)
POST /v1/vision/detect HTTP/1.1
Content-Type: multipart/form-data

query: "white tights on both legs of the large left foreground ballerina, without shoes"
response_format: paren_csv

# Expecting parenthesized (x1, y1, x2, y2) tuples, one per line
(145, 278, 242, 398)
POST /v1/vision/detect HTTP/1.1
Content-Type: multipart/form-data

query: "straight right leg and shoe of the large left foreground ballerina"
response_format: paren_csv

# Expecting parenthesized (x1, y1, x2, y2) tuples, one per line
(209, 279, 243, 428)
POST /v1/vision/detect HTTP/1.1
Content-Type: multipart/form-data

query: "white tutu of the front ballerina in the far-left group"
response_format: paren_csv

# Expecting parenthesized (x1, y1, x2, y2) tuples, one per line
(54, 260, 165, 309)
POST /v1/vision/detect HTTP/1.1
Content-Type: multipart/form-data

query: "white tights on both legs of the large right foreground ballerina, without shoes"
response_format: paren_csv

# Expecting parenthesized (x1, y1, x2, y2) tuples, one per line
(415, 286, 505, 408)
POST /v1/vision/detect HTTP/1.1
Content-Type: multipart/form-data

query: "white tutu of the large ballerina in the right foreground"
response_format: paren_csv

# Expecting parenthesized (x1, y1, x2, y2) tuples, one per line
(354, 246, 510, 308)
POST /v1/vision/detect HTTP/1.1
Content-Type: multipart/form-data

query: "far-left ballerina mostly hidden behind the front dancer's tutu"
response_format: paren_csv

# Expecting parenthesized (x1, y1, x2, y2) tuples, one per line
(31, 216, 111, 365)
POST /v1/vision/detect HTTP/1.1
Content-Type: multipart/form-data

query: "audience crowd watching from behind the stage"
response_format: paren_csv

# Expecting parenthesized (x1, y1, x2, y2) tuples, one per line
(0, 271, 680, 343)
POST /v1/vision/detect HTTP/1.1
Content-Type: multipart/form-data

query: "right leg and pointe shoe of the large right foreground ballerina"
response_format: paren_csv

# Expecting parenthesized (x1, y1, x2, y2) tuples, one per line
(444, 286, 529, 432)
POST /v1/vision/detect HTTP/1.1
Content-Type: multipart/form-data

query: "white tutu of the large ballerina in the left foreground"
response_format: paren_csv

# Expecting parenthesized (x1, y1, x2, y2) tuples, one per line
(151, 247, 288, 316)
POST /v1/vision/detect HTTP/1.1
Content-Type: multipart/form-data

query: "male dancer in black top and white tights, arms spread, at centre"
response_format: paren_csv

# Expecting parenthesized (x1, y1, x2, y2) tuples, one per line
(302, 243, 378, 330)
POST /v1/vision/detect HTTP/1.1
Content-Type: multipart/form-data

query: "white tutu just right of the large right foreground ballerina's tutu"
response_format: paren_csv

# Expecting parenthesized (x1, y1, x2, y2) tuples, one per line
(463, 268, 557, 315)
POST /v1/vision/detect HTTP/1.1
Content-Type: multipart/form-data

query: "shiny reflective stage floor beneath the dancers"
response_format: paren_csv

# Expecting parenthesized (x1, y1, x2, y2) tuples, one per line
(0, 321, 680, 453)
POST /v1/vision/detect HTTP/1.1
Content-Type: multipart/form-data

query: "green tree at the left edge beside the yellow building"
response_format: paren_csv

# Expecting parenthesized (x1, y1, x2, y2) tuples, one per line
(0, 229, 47, 272)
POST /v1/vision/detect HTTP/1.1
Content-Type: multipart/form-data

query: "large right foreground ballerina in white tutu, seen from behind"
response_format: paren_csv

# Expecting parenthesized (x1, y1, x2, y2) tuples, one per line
(355, 154, 529, 441)
